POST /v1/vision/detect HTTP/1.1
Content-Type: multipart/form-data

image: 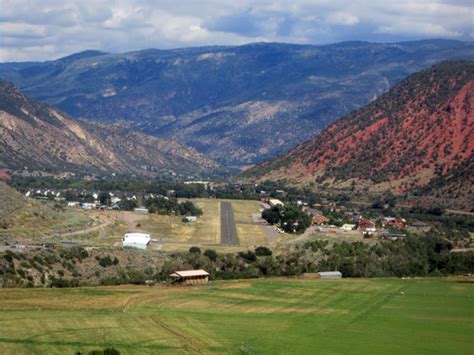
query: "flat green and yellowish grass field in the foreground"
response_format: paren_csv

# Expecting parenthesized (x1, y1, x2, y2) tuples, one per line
(0, 279, 474, 354)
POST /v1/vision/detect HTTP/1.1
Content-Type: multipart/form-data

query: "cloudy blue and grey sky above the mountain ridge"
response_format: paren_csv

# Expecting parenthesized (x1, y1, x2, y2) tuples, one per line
(0, 0, 474, 62)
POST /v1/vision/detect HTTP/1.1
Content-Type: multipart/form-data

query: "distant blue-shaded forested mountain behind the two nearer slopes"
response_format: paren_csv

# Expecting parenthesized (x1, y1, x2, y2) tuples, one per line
(0, 40, 474, 169)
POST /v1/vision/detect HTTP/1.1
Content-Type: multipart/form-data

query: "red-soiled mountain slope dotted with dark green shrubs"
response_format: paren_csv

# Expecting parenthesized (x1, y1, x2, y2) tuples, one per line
(243, 61, 474, 208)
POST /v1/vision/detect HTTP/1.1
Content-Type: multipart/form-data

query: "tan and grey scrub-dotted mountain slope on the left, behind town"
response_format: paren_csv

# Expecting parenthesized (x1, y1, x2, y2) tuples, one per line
(0, 82, 219, 177)
